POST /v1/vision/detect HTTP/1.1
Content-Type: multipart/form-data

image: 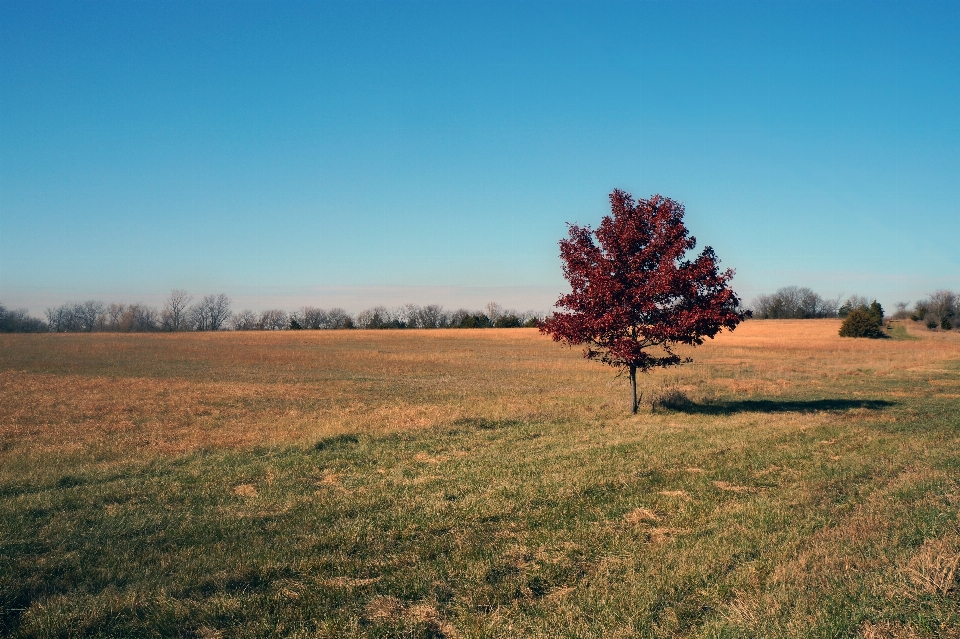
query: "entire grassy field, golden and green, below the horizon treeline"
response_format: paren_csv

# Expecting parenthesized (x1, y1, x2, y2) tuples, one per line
(0, 320, 960, 639)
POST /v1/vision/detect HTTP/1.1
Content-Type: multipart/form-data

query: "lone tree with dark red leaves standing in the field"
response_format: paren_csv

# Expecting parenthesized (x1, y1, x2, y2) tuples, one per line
(540, 190, 745, 413)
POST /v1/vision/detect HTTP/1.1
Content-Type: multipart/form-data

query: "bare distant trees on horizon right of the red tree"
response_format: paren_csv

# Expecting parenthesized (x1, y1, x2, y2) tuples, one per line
(752, 286, 960, 330)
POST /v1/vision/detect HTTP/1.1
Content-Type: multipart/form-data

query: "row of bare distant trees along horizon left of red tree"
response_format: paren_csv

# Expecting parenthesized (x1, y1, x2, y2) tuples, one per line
(0, 290, 542, 333)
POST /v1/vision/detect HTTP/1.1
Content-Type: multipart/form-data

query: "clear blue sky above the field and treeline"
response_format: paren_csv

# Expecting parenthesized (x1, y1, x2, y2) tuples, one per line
(0, 0, 960, 314)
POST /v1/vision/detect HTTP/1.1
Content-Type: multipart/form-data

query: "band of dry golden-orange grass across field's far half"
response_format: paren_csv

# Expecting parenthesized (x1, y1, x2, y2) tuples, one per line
(0, 320, 960, 462)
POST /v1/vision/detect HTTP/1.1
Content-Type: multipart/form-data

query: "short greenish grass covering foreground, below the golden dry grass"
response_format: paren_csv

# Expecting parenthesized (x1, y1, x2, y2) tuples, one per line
(0, 408, 960, 636)
